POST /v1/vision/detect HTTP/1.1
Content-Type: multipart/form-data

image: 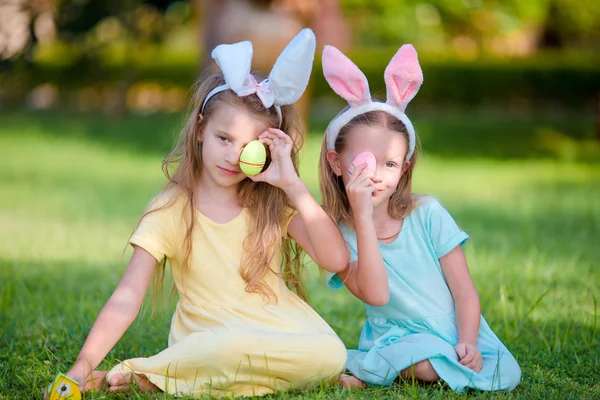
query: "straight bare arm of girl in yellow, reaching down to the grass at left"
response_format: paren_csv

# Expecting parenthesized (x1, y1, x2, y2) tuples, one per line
(67, 246, 157, 387)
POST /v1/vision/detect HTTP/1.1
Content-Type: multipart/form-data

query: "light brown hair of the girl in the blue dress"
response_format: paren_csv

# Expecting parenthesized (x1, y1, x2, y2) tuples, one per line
(319, 110, 418, 227)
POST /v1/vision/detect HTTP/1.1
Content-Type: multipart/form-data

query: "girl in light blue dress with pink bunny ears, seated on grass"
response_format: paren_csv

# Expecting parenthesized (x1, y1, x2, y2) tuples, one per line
(320, 45, 521, 392)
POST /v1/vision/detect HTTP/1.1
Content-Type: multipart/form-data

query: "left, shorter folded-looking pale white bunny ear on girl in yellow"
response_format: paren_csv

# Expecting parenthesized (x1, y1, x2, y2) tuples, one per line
(211, 41, 253, 92)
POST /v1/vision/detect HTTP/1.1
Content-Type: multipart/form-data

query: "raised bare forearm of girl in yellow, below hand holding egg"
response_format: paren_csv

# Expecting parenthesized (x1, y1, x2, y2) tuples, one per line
(286, 183, 350, 272)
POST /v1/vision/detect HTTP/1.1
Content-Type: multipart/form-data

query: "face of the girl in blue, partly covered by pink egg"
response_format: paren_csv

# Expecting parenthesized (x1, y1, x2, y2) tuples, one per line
(327, 125, 410, 208)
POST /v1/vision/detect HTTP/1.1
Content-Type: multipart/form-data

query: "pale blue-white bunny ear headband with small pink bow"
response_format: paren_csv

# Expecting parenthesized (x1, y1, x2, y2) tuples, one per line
(200, 28, 316, 124)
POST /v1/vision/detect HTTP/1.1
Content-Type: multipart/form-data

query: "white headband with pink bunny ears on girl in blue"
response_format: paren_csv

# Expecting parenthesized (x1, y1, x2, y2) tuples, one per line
(323, 44, 423, 160)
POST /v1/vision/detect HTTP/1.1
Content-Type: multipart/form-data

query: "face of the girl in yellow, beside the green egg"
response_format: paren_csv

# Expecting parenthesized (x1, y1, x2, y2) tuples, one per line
(198, 101, 269, 187)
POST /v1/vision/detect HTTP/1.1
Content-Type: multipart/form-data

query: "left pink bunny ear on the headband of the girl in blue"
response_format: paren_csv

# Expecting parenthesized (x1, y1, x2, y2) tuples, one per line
(322, 46, 371, 107)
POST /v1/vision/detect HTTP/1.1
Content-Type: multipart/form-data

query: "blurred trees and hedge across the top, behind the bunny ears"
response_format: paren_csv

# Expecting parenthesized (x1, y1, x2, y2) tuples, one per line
(0, 0, 600, 113)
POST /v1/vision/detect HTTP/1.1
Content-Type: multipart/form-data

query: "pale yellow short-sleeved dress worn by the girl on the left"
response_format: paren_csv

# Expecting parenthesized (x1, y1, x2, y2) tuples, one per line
(107, 195, 346, 397)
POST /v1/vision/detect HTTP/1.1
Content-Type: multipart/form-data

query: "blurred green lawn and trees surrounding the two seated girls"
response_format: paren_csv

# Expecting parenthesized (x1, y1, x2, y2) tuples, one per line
(0, 0, 600, 399)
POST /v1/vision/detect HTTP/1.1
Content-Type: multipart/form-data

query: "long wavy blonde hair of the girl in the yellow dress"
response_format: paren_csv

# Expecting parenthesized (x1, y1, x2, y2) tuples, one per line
(138, 72, 306, 302)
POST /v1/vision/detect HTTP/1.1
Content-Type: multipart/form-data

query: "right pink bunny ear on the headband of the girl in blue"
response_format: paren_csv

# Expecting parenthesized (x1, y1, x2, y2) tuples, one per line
(383, 44, 423, 112)
